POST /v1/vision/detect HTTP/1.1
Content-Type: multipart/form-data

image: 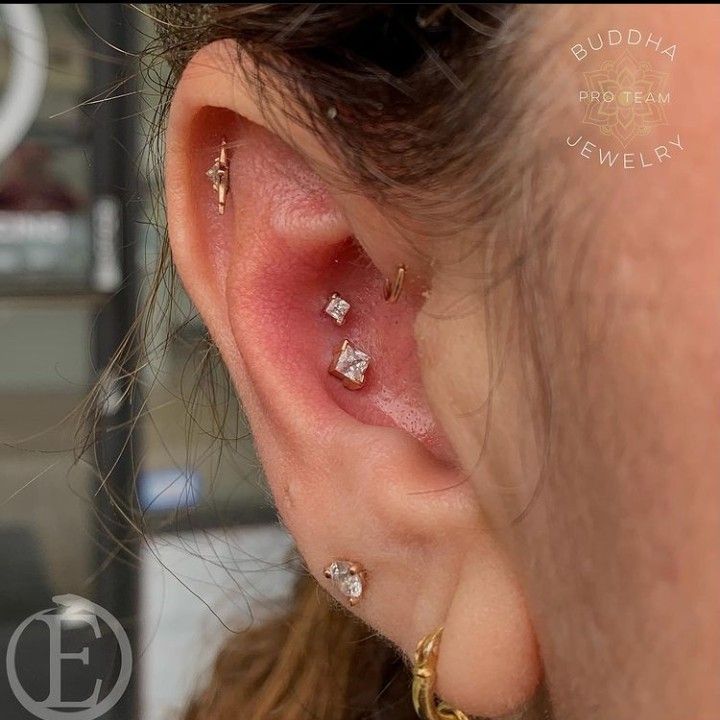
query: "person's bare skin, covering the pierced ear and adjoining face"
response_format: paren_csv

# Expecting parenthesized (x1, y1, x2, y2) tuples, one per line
(166, 6, 720, 720)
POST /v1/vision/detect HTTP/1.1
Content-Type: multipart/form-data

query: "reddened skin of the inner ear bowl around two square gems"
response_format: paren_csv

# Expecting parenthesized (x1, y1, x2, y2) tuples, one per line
(245, 238, 452, 462)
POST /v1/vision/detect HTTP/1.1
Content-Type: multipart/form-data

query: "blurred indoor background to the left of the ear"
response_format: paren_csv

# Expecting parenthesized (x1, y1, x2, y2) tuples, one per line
(0, 3, 294, 720)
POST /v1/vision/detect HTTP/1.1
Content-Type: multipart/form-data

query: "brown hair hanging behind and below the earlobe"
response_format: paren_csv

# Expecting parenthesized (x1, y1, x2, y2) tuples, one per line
(185, 576, 415, 720)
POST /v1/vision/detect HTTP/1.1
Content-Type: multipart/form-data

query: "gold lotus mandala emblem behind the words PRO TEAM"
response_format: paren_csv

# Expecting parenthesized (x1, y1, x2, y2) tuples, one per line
(583, 50, 670, 148)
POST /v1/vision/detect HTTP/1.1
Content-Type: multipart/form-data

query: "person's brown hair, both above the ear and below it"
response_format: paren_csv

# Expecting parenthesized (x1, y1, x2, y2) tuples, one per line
(140, 4, 556, 720)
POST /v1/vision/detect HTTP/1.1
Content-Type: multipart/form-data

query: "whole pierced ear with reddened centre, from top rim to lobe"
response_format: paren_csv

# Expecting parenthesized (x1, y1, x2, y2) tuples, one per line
(166, 41, 539, 715)
